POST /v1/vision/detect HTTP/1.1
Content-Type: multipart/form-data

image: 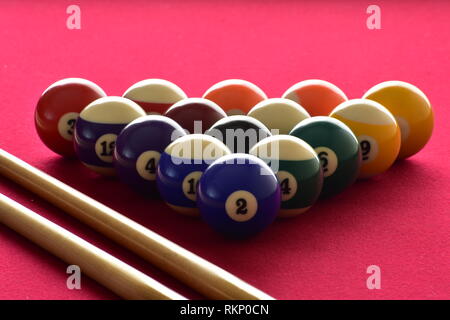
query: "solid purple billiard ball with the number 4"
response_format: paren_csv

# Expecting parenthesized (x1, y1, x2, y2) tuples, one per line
(113, 115, 185, 197)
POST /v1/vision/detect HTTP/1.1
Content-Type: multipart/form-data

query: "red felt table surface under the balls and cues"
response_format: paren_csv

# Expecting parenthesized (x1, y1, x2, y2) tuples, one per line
(0, 0, 450, 299)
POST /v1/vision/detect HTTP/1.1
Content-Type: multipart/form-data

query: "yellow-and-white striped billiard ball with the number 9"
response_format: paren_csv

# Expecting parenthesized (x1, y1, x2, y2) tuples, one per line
(330, 99, 400, 178)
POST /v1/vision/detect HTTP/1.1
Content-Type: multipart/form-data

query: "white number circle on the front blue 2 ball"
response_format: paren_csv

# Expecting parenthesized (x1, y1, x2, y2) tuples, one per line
(225, 190, 258, 222)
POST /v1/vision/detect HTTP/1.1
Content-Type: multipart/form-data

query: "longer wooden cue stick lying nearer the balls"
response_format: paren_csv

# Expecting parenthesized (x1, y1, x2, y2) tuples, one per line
(0, 149, 273, 300)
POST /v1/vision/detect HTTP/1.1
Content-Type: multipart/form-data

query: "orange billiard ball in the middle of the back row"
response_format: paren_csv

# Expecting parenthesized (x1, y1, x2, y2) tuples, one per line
(203, 79, 267, 115)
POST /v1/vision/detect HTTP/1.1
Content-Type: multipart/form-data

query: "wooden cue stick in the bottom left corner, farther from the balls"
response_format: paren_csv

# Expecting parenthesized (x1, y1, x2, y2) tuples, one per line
(0, 193, 186, 300)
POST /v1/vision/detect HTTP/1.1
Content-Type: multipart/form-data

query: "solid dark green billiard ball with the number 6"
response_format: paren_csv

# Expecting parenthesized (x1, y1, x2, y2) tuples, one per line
(290, 116, 361, 197)
